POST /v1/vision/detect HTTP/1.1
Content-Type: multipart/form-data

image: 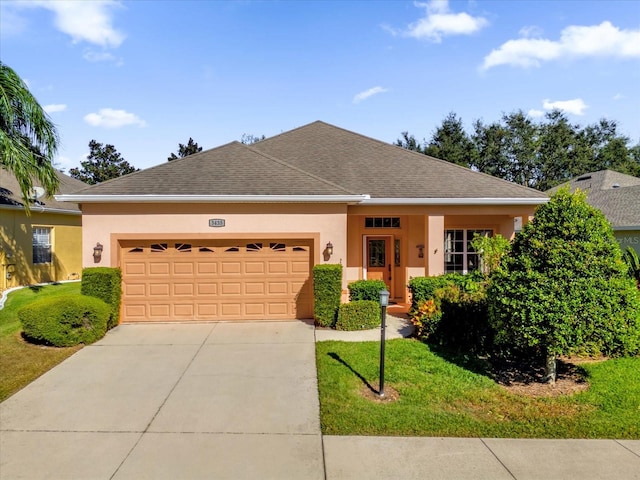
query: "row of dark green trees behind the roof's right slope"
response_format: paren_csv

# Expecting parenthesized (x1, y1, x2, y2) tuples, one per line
(395, 110, 640, 191)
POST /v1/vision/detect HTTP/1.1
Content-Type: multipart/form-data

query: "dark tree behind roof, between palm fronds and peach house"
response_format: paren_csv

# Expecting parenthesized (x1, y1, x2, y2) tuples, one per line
(69, 140, 138, 185)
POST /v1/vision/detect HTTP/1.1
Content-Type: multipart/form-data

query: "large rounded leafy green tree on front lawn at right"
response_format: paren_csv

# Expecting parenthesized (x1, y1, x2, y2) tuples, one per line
(487, 189, 640, 375)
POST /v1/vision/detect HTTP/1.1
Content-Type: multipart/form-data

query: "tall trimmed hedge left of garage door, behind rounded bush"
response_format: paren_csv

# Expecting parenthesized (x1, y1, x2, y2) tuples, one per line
(80, 267, 122, 330)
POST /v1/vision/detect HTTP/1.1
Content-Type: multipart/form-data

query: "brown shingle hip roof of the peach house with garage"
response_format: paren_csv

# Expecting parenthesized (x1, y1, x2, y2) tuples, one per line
(62, 121, 547, 203)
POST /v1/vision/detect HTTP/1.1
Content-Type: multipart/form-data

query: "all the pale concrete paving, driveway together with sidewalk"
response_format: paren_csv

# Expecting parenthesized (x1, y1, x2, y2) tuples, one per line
(0, 322, 640, 480)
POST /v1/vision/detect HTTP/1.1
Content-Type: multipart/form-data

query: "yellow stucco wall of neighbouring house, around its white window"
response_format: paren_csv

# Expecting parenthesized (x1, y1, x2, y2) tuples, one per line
(0, 208, 82, 291)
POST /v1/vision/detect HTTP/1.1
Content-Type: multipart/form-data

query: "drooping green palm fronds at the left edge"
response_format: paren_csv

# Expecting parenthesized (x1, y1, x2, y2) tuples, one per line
(0, 62, 59, 211)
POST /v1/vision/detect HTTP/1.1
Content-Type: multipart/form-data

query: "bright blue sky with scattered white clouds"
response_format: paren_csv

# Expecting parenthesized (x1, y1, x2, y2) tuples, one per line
(0, 0, 640, 170)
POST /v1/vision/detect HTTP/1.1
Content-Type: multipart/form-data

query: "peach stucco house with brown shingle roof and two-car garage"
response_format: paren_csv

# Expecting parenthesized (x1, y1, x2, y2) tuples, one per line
(57, 122, 548, 321)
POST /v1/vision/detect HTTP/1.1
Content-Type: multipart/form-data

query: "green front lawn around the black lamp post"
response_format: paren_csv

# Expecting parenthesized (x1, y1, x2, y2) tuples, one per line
(316, 339, 640, 439)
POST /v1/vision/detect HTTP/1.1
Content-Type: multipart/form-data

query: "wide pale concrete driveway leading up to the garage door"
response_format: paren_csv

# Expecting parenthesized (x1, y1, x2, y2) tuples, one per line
(0, 322, 324, 480)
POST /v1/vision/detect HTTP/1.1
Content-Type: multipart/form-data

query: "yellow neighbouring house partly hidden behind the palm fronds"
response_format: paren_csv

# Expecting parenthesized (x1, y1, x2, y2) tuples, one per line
(0, 168, 87, 291)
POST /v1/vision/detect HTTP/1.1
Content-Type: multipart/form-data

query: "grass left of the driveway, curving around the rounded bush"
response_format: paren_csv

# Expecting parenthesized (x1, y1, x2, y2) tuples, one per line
(0, 282, 82, 402)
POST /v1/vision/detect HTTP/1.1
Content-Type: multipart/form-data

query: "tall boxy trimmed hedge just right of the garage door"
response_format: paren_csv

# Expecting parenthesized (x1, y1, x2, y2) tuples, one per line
(313, 264, 342, 327)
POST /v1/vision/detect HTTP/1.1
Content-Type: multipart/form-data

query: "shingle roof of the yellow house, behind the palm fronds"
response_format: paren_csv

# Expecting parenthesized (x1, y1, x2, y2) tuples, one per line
(0, 167, 87, 213)
